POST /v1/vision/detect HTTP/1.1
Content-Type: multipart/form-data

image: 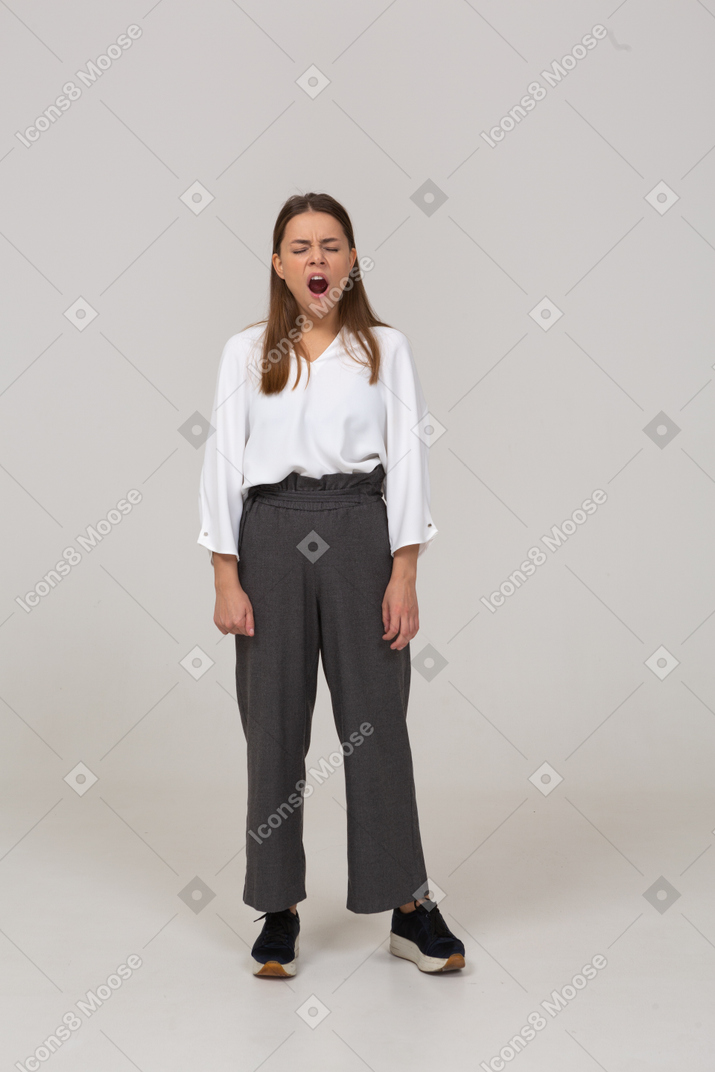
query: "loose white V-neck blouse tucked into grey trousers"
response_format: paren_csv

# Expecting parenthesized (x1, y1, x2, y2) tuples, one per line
(197, 324, 437, 557)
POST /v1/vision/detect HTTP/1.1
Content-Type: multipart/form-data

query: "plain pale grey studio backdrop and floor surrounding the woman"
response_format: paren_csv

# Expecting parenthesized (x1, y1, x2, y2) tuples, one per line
(0, 0, 715, 1072)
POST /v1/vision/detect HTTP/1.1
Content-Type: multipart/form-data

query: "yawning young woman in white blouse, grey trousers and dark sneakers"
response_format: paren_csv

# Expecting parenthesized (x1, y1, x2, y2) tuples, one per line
(198, 193, 464, 977)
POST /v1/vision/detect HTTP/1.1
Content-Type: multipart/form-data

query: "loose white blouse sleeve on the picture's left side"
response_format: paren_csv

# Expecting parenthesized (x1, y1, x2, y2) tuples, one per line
(197, 336, 249, 557)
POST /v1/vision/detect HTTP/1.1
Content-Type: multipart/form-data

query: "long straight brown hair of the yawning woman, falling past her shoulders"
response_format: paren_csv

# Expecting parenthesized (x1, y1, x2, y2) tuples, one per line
(247, 193, 390, 394)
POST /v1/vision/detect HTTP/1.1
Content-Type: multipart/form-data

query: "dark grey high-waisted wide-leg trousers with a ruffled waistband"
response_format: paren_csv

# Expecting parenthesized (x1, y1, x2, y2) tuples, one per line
(236, 464, 427, 912)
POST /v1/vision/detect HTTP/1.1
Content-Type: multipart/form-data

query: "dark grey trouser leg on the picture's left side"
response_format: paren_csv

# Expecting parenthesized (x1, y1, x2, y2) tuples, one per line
(236, 502, 318, 912)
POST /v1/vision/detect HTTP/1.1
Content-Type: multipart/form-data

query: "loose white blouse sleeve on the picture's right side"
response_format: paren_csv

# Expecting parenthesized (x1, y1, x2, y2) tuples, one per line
(381, 331, 437, 557)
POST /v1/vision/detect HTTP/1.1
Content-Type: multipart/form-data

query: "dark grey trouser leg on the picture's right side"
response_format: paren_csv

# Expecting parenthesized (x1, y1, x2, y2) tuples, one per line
(315, 500, 427, 912)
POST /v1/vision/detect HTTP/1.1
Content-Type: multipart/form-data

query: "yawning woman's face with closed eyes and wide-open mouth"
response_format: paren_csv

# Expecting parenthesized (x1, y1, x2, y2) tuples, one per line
(272, 212, 357, 317)
